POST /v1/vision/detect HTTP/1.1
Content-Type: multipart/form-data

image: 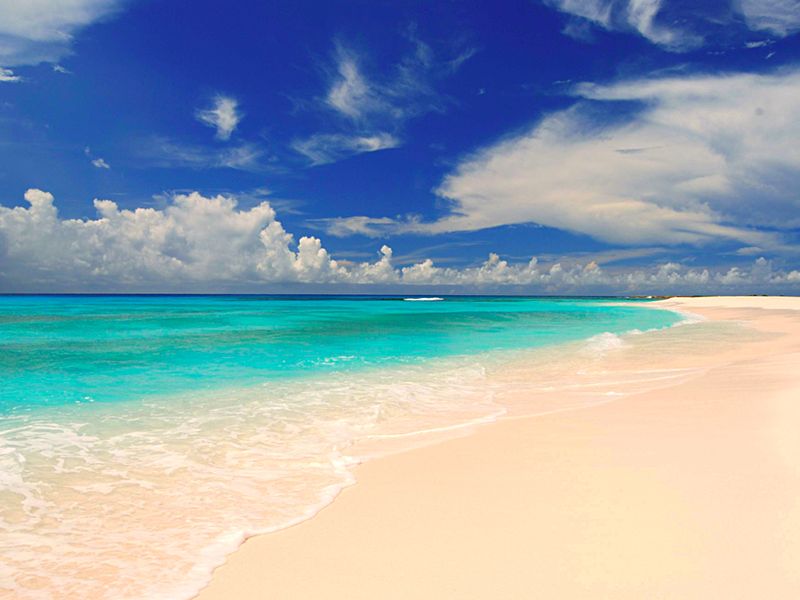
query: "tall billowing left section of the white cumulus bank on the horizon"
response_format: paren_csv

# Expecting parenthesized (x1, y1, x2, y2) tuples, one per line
(0, 190, 346, 286)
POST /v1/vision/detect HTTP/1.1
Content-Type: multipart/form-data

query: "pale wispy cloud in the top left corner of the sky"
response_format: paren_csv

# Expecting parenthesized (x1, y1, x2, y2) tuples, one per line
(0, 0, 123, 67)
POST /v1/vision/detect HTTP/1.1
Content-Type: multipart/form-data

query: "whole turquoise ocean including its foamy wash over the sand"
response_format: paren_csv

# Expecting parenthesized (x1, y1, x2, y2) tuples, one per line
(0, 296, 684, 600)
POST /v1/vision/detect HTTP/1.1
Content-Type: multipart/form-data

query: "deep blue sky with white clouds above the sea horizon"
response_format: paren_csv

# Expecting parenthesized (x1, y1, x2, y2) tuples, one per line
(0, 0, 800, 293)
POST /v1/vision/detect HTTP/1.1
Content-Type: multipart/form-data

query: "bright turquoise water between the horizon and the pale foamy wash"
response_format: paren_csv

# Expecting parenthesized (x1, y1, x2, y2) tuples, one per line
(0, 296, 679, 413)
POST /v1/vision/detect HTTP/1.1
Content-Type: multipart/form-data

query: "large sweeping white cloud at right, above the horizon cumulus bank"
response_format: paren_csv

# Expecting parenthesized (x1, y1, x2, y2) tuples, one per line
(318, 69, 800, 251)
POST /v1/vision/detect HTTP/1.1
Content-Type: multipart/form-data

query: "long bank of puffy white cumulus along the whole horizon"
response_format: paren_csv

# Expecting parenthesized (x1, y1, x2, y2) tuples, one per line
(0, 189, 800, 293)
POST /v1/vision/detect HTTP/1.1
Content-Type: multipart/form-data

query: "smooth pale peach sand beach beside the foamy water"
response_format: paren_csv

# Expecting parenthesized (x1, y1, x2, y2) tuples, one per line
(199, 297, 800, 600)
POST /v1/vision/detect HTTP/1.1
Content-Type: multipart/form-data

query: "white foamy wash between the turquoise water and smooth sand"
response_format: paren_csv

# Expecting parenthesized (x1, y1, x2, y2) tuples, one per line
(0, 357, 501, 600)
